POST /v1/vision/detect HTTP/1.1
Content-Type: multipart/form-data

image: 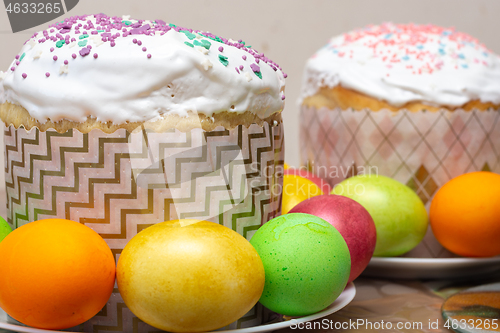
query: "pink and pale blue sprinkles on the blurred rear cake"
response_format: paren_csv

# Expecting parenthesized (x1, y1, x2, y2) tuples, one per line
(326, 23, 490, 75)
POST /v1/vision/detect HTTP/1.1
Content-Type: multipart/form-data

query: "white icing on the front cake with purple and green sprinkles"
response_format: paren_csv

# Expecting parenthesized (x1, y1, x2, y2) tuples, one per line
(0, 16, 286, 124)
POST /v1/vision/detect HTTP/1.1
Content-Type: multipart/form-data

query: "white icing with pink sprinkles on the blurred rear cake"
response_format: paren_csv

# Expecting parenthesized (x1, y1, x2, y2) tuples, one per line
(302, 23, 500, 107)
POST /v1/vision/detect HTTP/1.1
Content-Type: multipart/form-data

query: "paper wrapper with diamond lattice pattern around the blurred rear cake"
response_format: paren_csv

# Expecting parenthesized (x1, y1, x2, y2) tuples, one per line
(300, 106, 500, 258)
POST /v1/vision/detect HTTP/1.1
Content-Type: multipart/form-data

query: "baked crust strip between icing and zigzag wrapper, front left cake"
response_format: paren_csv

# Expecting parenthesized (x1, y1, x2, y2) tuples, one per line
(0, 102, 281, 133)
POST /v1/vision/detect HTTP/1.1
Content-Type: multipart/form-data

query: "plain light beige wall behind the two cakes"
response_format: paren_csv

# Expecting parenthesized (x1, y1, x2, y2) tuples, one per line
(0, 0, 500, 171)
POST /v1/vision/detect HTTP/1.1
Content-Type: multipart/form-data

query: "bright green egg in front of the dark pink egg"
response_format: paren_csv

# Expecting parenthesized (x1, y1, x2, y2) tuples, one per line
(250, 213, 351, 316)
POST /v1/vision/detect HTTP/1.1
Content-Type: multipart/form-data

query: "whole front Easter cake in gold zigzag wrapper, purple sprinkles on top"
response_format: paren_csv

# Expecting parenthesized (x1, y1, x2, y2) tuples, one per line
(0, 14, 286, 331)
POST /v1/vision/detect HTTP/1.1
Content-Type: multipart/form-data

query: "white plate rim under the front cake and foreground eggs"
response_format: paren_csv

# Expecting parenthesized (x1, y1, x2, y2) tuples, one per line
(0, 282, 356, 333)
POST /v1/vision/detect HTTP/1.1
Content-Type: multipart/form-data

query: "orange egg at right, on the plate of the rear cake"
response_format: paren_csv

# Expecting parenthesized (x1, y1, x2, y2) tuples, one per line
(429, 171, 500, 257)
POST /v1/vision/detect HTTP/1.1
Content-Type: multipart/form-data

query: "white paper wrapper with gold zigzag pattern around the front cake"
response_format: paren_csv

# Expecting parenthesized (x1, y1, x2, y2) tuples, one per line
(4, 122, 284, 332)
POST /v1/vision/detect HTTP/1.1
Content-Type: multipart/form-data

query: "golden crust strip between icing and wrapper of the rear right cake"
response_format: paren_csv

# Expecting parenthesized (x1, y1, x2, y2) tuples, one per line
(302, 85, 500, 112)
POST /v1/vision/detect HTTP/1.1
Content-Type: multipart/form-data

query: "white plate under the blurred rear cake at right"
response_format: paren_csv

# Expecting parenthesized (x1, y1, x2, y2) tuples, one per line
(363, 256, 500, 279)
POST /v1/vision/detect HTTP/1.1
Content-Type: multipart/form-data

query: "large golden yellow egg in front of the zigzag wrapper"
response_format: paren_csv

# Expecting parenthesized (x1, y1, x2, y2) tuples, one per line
(117, 220, 265, 332)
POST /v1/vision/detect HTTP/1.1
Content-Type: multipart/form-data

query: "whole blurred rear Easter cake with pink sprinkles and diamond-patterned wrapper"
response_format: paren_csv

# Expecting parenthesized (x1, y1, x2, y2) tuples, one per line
(300, 23, 500, 257)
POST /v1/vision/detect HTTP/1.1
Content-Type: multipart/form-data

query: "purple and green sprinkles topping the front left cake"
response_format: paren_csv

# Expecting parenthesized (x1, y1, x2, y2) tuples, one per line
(11, 14, 286, 91)
